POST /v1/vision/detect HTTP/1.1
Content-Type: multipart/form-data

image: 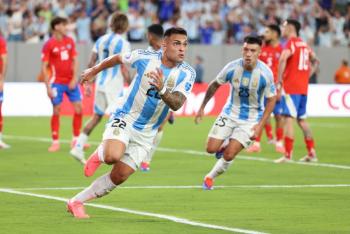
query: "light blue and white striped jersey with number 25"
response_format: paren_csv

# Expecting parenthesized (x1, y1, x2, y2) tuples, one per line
(216, 58, 276, 122)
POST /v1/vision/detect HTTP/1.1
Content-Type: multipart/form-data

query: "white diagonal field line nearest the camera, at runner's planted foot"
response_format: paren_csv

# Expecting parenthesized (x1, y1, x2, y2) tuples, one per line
(0, 189, 264, 234)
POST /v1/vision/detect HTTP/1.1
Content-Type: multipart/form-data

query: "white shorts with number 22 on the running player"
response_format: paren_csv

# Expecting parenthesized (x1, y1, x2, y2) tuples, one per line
(103, 118, 157, 171)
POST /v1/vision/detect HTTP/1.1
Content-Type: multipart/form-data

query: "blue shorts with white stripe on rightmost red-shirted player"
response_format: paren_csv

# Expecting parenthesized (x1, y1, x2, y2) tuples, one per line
(282, 94, 307, 119)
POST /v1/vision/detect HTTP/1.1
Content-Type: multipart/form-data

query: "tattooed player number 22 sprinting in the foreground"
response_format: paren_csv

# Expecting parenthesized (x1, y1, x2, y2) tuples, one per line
(67, 28, 195, 218)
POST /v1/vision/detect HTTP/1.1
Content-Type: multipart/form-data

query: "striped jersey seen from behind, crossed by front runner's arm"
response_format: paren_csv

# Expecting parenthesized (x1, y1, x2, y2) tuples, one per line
(92, 33, 130, 96)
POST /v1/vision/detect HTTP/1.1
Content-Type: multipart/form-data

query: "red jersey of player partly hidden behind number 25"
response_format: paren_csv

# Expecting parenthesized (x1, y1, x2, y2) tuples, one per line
(259, 44, 282, 84)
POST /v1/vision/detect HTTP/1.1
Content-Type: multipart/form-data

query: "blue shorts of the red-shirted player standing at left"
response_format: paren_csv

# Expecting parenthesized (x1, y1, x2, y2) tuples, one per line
(51, 83, 81, 106)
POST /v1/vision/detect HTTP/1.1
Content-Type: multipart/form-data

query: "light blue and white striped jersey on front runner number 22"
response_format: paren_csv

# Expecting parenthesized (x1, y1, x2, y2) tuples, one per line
(114, 50, 196, 131)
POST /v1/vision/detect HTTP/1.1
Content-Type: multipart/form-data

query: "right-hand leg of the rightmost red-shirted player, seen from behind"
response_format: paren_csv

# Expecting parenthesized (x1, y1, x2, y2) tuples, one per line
(298, 95, 317, 162)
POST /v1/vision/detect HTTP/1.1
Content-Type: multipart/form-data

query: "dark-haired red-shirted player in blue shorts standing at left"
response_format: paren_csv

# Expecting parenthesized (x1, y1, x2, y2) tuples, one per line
(42, 17, 82, 152)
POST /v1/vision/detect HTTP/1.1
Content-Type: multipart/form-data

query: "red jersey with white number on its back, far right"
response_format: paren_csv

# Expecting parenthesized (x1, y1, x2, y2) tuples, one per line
(283, 37, 311, 95)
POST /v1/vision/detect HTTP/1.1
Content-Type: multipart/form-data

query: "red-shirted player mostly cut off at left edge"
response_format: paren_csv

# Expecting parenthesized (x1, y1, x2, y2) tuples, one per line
(0, 31, 10, 149)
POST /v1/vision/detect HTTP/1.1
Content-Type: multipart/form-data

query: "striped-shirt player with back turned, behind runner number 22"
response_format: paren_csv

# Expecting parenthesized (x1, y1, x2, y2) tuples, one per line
(70, 13, 130, 160)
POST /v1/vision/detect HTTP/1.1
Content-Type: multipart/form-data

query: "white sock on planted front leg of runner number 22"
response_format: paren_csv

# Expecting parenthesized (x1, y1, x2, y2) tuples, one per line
(72, 172, 117, 203)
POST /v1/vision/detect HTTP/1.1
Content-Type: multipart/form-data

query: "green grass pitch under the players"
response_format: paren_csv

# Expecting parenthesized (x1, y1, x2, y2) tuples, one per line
(0, 117, 350, 234)
